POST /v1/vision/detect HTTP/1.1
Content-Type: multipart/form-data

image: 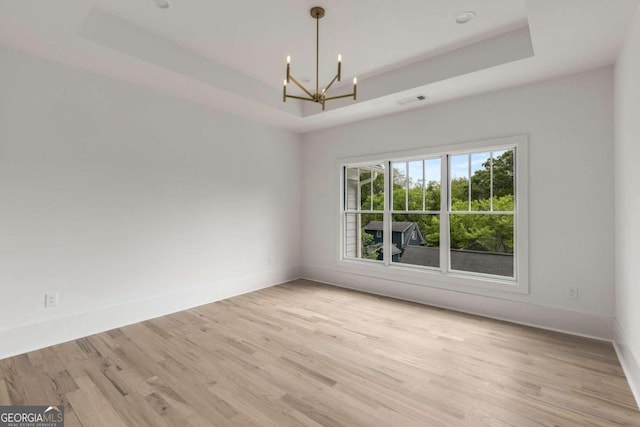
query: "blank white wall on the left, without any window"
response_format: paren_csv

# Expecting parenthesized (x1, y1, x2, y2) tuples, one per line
(0, 48, 301, 358)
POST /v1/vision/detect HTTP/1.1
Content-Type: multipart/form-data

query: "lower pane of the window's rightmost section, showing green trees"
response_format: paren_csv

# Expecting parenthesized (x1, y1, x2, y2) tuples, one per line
(449, 214, 514, 277)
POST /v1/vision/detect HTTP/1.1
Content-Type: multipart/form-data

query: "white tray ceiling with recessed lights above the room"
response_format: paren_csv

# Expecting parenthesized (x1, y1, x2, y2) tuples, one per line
(0, 0, 638, 133)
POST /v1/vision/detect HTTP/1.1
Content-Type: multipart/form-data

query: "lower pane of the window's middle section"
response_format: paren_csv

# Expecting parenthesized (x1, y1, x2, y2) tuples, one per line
(391, 214, 440, 268)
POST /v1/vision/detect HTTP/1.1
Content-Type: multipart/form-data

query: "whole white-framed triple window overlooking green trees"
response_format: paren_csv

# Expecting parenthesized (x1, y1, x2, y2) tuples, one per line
(340, 136, 528, 292)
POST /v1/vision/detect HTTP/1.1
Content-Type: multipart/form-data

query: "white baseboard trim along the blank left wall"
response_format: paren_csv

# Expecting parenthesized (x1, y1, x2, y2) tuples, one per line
(0, 266, 301, 360)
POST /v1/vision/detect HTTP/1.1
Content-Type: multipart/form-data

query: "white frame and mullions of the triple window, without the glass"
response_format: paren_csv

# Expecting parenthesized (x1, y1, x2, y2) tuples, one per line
(337, 135, 529, 295)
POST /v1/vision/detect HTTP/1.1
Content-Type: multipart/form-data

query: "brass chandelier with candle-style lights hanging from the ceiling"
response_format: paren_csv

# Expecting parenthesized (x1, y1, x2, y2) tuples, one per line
(282, 6, 358, 110)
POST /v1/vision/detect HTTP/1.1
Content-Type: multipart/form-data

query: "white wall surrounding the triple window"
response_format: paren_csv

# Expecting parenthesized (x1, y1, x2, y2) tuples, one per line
(302, 67, 614, 338)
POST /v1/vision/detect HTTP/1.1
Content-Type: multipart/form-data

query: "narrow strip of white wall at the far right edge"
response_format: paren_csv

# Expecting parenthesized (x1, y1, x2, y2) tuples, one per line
(615, 2, 640, 402)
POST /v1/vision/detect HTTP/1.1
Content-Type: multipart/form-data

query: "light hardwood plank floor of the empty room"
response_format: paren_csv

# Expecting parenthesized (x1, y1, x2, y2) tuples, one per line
(0, 280, 640, 427)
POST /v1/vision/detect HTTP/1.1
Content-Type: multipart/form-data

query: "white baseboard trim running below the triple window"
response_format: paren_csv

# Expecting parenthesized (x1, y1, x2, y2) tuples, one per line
(302, 265, 613, 341)
